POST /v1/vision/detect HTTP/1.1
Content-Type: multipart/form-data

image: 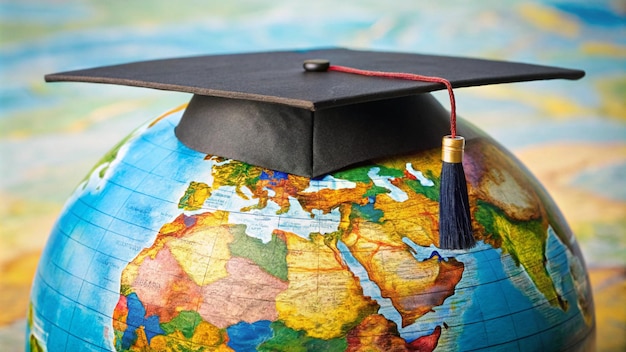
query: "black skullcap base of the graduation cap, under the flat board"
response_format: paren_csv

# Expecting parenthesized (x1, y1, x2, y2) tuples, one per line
(176, 94, 475, 177)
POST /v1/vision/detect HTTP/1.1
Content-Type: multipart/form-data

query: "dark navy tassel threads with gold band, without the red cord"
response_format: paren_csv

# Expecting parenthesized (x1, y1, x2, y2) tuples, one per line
(439, 136, 476, 249)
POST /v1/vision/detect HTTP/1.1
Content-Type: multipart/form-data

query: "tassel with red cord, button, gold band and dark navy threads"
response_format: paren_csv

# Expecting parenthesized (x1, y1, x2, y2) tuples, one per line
(303, 60, 476, 249)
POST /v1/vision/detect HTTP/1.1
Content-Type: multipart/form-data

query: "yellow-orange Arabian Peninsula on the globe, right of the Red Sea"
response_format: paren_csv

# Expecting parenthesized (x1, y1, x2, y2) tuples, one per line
(342, 219, 463, 326)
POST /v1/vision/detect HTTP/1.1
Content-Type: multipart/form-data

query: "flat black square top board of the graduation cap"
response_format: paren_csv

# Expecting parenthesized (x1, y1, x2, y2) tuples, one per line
(45, 49, 584, 111)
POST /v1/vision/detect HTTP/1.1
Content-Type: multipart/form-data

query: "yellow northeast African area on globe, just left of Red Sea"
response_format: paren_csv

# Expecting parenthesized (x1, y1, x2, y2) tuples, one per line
(276, 232, 377, 339)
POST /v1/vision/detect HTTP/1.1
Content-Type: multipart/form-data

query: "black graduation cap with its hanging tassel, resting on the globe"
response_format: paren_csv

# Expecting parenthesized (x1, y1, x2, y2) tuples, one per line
(45, 49, 584, 248)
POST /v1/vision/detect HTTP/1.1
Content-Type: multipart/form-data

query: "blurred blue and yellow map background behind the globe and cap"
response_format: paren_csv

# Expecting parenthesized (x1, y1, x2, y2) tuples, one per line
(0, 0, 626, 351)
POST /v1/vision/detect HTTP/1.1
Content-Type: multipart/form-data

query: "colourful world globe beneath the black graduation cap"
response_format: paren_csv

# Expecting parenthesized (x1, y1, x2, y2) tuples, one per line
(26, 103, 595, 351)
